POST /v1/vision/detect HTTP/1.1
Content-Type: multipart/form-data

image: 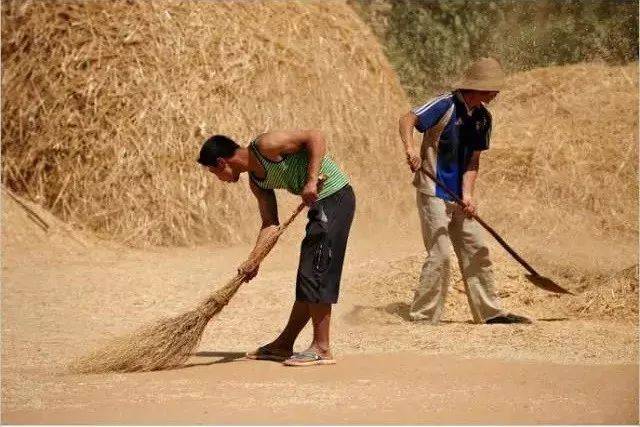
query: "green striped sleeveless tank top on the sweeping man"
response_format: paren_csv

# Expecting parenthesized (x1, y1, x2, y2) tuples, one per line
(249, 140, 349, 200)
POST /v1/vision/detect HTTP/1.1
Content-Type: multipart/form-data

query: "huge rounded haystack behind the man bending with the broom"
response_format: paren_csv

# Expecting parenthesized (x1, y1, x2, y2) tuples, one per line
(2, 0, 410, 245)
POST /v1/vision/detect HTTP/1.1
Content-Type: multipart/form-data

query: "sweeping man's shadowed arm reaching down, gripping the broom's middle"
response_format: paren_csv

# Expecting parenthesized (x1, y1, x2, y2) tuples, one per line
(238, 181, 279, 282)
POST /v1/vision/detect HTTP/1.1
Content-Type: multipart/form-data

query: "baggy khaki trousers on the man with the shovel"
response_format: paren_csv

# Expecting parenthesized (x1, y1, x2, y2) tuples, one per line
(409, 191, 506, 324)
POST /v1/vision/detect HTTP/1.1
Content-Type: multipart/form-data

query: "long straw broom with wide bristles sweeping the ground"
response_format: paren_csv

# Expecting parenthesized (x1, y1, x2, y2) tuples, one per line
(69, 203, 305, 374)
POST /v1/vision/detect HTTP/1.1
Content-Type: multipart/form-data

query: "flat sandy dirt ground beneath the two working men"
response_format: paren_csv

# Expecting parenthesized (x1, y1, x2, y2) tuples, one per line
(2, 198, 638, 424)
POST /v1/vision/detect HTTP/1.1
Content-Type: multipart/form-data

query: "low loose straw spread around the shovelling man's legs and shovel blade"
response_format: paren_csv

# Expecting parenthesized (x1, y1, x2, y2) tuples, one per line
(351, 252, 638, 324)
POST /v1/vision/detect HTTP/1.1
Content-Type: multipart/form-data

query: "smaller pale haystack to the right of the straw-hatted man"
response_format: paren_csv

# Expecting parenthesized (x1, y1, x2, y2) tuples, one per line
(480, 63, 638, 239)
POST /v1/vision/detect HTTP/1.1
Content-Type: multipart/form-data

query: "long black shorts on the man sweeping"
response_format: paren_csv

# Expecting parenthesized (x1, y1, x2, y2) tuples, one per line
(296, 185, 356, 304)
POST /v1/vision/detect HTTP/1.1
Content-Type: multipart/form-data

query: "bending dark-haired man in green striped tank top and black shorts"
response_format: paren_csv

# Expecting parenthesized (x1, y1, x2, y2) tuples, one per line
(198, 130, 355, 366)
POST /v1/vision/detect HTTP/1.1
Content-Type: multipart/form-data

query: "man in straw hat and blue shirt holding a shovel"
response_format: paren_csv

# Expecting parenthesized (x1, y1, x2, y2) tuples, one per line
(400, 58, 531, 324)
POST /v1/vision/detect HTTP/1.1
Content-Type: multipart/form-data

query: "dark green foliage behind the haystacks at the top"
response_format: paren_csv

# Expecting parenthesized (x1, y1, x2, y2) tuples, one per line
(350, 0, 638, 100)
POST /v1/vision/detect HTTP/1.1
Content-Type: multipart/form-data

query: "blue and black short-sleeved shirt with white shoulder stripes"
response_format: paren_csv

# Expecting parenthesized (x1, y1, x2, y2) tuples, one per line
(411, 91, 491, 201)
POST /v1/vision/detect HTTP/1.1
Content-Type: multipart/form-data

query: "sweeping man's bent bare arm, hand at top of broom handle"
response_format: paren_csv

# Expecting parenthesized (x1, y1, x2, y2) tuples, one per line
(260, 130, 327, 205)
